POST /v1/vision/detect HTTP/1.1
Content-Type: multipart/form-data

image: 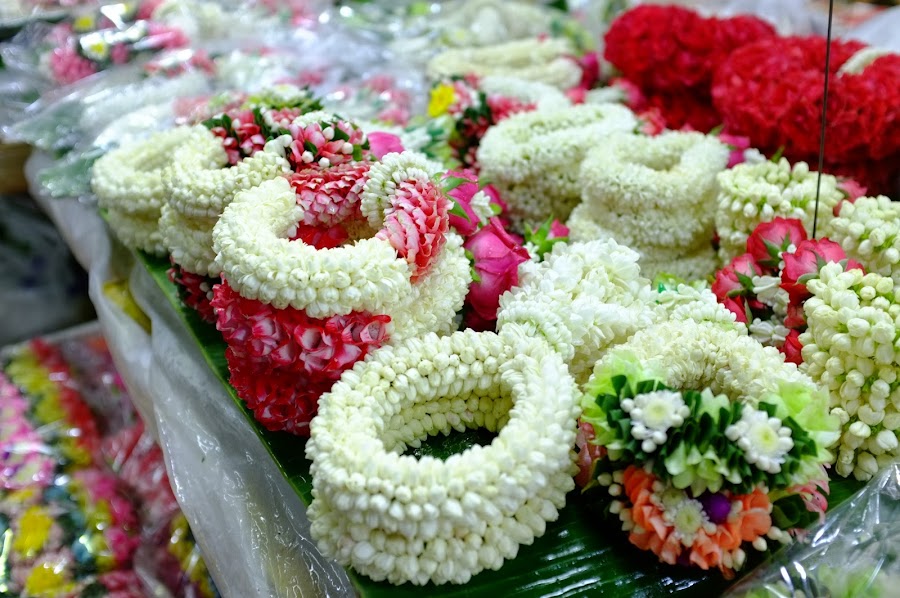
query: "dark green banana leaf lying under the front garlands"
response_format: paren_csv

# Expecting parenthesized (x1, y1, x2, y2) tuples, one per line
(138, 254, 862, 598)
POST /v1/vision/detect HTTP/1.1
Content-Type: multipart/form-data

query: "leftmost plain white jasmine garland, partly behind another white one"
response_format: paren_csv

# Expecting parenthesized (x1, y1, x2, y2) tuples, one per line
(91, 127, 193, 220)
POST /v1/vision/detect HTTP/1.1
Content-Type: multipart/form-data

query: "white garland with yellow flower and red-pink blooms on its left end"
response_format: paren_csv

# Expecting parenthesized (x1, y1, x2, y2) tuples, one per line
(428, 75, 568, 168)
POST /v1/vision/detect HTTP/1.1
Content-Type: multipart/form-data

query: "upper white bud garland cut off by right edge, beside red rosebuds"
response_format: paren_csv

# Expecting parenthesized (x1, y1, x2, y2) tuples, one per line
(828, 195, 900, 286)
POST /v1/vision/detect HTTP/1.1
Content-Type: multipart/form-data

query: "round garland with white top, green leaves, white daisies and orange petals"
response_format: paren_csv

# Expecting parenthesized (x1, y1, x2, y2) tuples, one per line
(582, 320, 838, 577)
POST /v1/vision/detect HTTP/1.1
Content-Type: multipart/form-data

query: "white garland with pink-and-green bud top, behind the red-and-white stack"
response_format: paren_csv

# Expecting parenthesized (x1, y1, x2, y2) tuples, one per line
(159, 85, 326, 321)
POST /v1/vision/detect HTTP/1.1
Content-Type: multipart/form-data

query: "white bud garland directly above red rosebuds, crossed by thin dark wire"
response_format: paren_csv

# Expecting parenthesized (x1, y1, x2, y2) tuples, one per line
(716, 158, 844, 263)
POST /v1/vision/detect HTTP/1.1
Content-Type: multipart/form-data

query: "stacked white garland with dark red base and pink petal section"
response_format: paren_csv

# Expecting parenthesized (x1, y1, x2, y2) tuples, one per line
(212, 153, 471, 434)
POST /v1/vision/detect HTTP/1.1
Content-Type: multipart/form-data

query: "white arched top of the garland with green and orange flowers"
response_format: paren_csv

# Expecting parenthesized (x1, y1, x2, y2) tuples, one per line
(594, 320, 821, 405)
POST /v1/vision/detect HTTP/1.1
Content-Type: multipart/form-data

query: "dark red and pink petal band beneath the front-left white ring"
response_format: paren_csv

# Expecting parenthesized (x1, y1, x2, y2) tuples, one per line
(212, 282, 390, 435)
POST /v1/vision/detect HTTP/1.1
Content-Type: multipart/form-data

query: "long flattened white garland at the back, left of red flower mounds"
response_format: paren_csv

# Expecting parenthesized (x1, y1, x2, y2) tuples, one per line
(427, 38, 581, 90)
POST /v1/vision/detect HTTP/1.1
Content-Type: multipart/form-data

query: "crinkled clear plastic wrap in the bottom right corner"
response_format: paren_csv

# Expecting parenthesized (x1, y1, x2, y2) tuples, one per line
(728, 464, 900, 598)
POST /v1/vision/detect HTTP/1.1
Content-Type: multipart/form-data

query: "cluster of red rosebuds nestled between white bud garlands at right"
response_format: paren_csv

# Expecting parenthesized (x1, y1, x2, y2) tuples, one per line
(712, 218, 862, 364)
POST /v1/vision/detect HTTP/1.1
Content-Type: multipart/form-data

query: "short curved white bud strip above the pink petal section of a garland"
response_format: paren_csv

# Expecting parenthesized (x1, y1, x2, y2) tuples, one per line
(359, 152, 442, 229)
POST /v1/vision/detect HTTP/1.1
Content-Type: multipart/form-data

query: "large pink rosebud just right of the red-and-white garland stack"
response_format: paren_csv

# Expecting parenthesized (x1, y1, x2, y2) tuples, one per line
(464, 218, 529, 322)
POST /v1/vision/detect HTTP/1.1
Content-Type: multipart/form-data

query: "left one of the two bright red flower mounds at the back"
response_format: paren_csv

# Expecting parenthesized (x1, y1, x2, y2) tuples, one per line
(604, 5, 775, 131)
